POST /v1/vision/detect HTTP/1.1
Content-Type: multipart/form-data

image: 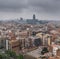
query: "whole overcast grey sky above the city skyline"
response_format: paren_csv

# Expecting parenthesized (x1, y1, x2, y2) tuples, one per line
(0, 0, 60, 20)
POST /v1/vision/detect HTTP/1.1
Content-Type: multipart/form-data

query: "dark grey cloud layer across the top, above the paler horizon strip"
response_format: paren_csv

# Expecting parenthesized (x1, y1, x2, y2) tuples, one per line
(0, 0, 60, 13)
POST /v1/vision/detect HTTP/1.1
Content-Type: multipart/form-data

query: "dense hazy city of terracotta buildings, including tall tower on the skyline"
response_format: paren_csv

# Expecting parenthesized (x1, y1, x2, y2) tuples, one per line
(0, 14, 60, 59)
